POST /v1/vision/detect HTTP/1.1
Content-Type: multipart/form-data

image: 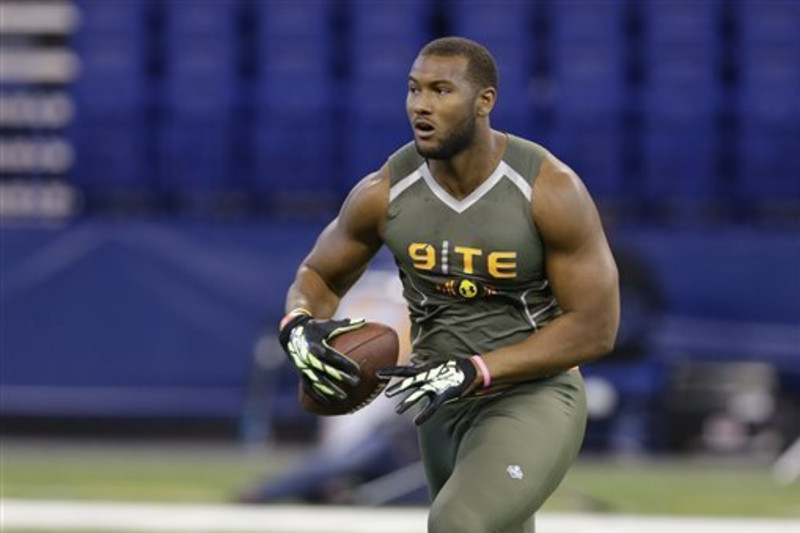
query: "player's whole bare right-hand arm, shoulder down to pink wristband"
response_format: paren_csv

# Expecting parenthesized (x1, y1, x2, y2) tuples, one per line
(483, 157, 619, 384)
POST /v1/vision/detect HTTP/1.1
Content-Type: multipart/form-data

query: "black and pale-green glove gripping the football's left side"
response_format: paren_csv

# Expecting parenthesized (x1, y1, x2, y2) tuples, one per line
(278, 314, 365, 404)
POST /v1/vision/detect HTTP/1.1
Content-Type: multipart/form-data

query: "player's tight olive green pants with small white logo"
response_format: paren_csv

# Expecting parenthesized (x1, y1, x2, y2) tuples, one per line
(419, 369, 586, 533)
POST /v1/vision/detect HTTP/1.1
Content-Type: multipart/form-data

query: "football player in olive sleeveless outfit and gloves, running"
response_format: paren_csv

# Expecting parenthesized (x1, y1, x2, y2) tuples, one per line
(280, 37, 619, 533)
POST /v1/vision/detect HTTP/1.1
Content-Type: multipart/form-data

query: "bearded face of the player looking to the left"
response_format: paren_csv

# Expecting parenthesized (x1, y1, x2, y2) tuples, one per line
(406, 56, 477, 159)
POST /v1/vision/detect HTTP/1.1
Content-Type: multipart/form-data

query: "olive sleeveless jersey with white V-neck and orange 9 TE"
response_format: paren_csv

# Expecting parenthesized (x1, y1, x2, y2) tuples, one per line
(383, 135, 561, 362)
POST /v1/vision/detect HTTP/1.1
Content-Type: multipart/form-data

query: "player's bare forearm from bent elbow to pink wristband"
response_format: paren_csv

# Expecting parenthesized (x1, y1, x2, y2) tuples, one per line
(483, 312, 619, 385)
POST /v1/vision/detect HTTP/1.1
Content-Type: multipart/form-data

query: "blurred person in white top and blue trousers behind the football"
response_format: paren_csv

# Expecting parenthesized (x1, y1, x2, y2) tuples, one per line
(234, 268, 424, 504)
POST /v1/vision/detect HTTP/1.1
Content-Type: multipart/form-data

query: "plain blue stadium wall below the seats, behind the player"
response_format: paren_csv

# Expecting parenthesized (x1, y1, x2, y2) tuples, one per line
(0, 222, 800, 419)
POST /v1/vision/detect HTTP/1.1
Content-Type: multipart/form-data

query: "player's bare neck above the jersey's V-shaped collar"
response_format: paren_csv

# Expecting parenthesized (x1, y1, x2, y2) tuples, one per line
(428, 128, 507, 200)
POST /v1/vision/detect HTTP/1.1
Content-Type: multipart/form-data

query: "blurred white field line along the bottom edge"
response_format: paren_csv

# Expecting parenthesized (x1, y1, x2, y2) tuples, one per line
(0, 499, 800, 533)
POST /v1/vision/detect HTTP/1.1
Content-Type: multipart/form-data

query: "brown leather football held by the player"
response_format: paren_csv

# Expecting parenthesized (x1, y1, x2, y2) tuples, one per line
(298, 322, 400, 416)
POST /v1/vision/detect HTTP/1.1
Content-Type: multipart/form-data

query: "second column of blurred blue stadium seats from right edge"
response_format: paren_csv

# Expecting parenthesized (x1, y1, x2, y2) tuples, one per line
(640, 0, 723, 215)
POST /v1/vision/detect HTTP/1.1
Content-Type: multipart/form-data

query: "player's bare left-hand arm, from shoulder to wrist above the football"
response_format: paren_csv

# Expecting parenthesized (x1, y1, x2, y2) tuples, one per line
(286, 167, 389, 318)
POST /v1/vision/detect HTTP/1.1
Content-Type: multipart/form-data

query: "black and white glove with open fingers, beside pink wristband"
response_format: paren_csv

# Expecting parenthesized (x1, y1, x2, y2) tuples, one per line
(378, 358, 478, 426)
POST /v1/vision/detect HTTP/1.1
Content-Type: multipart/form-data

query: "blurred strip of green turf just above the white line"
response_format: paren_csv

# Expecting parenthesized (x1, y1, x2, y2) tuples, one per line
(2, 441, 800, 517)
